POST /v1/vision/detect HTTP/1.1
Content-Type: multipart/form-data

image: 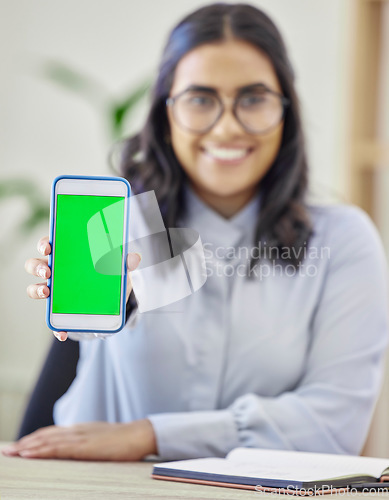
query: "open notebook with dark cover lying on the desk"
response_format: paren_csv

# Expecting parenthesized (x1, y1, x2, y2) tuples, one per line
(151, 448, 389, 496)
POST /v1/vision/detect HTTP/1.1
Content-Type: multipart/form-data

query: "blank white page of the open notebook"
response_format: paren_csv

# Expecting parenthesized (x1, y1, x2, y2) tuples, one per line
(225, 448, 389, 482)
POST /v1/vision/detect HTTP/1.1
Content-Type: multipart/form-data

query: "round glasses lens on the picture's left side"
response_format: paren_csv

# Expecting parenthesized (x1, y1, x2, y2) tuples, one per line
(173, 90, 221, 132)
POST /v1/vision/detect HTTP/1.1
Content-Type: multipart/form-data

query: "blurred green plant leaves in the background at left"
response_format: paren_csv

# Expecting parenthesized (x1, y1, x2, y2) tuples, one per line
(0, 61, 151, 236)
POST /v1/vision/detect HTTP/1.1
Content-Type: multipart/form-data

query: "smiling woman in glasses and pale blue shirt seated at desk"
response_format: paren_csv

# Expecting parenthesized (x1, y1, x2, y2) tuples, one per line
(6, 4, 387, 460)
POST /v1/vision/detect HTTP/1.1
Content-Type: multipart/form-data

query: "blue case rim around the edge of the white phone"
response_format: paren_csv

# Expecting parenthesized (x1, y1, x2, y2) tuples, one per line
(46, 175, 131, 333)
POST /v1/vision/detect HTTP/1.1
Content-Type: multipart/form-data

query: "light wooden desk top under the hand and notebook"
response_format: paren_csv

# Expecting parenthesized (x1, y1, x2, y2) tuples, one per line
(0, 443, 382, 500)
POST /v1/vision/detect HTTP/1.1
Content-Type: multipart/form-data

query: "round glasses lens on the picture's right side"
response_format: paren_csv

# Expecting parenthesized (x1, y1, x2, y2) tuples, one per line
(236, 89, 284, 133)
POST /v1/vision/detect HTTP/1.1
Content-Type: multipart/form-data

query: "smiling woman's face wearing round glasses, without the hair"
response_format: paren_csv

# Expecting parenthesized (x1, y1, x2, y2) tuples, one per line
(168, 37, 283, 217)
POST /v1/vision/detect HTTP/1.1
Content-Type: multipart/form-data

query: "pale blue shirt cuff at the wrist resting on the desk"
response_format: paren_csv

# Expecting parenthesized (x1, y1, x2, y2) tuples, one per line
(147, 410, 239, 460)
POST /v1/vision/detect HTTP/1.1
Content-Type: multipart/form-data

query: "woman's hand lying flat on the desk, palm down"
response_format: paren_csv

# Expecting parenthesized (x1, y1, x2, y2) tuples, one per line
(2, 419, 158, 462)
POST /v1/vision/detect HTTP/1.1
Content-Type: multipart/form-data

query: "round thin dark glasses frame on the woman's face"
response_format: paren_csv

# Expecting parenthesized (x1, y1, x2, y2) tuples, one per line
(165, 83, 290, 135)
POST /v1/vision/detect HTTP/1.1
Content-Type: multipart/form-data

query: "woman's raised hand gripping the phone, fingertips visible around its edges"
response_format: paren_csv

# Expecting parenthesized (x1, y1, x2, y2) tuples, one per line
(24, 236, 141, 341)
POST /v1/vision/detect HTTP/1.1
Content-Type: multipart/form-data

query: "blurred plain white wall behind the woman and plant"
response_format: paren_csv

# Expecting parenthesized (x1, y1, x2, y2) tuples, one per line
(0, 0, 358, 439)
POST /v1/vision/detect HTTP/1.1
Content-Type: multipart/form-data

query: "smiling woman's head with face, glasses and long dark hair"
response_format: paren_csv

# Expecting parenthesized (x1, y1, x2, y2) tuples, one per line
(119, 4, 311, 266)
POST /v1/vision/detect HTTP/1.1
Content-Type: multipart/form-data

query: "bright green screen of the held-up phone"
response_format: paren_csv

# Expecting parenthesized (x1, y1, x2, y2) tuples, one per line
(52, 194, 124, 315)
